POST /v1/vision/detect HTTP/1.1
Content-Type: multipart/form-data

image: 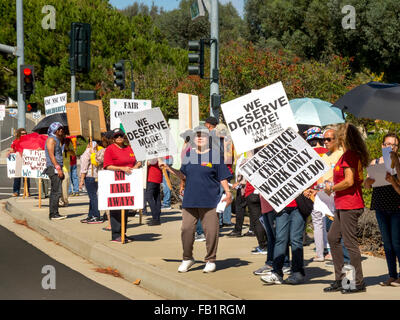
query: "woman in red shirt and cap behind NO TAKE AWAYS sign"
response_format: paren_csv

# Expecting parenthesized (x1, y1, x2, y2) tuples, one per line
(103, 129, 142, 242)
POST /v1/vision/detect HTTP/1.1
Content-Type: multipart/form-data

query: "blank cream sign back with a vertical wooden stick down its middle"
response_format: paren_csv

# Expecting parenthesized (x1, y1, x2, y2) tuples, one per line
(178, 93, 200, 133)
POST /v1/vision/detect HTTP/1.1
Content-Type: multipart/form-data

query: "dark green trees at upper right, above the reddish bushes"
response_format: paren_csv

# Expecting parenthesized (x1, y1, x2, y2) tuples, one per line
(245, 0, 400, 81)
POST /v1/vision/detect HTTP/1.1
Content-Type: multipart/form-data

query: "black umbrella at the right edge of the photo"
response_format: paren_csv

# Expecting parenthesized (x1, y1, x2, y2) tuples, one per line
(333, 82, 400, 122)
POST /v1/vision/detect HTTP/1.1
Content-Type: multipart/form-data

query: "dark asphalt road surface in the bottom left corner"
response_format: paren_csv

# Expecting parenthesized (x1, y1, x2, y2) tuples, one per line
(0, 226, 127, 300)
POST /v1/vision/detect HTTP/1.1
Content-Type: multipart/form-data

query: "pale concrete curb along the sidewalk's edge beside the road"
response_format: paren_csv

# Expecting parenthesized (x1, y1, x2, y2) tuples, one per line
(5, 198, 238, 300)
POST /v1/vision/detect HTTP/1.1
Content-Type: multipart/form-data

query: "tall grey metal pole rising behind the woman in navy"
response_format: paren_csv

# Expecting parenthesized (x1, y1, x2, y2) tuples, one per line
(210, 0, 219, 119)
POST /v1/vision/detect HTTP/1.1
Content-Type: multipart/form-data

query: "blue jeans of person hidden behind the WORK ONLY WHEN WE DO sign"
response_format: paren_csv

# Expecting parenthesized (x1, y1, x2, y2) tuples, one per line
(273, 208, 304, 277)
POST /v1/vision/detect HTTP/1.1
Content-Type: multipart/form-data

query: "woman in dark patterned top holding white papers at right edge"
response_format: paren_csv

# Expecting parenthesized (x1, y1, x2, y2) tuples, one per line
(364, 133, 400, 286)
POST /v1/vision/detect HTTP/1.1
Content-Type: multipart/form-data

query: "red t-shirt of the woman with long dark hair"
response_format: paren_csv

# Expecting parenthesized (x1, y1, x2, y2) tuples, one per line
(333, 150, 364, 210)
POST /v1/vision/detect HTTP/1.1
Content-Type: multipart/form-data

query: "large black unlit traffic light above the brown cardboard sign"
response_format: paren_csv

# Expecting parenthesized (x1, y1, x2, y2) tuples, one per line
(69, 22, 91, 74)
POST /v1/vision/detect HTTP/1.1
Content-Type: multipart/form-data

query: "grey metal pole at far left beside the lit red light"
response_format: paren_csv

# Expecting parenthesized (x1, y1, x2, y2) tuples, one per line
(16, 0, 25, 128)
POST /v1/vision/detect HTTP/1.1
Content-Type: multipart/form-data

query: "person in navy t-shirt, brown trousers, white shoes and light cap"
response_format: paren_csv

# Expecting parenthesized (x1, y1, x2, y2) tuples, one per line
(167, 126, 232, 273)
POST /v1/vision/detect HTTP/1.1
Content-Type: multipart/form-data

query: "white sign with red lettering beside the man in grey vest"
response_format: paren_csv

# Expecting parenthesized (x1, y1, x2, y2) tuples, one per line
(21, 149, 49, 179)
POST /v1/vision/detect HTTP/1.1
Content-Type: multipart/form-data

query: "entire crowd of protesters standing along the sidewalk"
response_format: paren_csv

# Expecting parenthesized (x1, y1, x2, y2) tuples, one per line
(7, 117, 400, 294)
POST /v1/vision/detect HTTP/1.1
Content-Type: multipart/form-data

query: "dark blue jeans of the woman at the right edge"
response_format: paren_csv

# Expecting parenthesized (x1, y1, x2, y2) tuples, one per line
(376, 210, 400, 279)
